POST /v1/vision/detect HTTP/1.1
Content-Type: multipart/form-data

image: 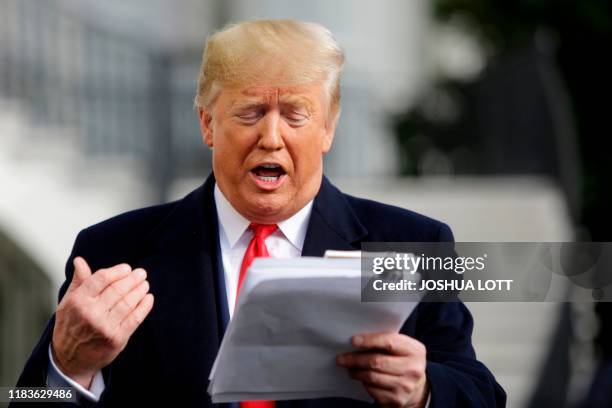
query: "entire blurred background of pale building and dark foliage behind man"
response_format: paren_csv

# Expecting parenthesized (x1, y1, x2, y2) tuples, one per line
(0, 0, 612, 407)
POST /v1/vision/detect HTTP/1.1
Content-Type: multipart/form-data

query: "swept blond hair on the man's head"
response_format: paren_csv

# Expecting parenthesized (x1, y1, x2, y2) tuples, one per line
(194, 20, 344, 112)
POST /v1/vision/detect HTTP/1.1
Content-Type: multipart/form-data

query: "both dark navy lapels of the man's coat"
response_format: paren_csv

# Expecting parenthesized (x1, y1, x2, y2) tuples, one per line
(130, 175, 367, 398)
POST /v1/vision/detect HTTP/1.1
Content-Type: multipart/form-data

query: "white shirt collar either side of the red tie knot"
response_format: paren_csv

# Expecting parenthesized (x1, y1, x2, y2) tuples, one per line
(214, 184, 313, 251)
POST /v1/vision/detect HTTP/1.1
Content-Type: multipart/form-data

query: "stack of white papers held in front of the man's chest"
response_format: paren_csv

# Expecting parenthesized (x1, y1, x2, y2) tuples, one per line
(208, 257, 416, 403)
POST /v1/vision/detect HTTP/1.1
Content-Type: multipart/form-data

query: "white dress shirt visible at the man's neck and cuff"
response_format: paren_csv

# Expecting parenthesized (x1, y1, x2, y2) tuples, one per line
(47, 184, 312, 402)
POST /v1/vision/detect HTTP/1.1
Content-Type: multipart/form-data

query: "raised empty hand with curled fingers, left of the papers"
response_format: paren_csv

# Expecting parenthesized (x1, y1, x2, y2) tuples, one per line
(51, 257, 153, 388)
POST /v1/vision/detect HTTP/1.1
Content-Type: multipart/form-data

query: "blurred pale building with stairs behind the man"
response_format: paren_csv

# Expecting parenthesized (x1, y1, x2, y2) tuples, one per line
(0, 0, 570, 406)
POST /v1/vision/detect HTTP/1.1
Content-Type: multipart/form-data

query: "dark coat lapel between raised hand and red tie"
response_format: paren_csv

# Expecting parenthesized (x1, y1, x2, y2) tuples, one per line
(137, 176, 227, 389)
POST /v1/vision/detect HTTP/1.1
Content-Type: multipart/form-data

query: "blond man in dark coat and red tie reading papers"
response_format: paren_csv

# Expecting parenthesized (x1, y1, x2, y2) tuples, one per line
(18, 20, 505, 407)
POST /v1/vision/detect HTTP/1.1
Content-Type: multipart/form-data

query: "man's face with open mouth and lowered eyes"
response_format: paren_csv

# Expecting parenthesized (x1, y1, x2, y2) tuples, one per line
(200, 83, 336, 223)
